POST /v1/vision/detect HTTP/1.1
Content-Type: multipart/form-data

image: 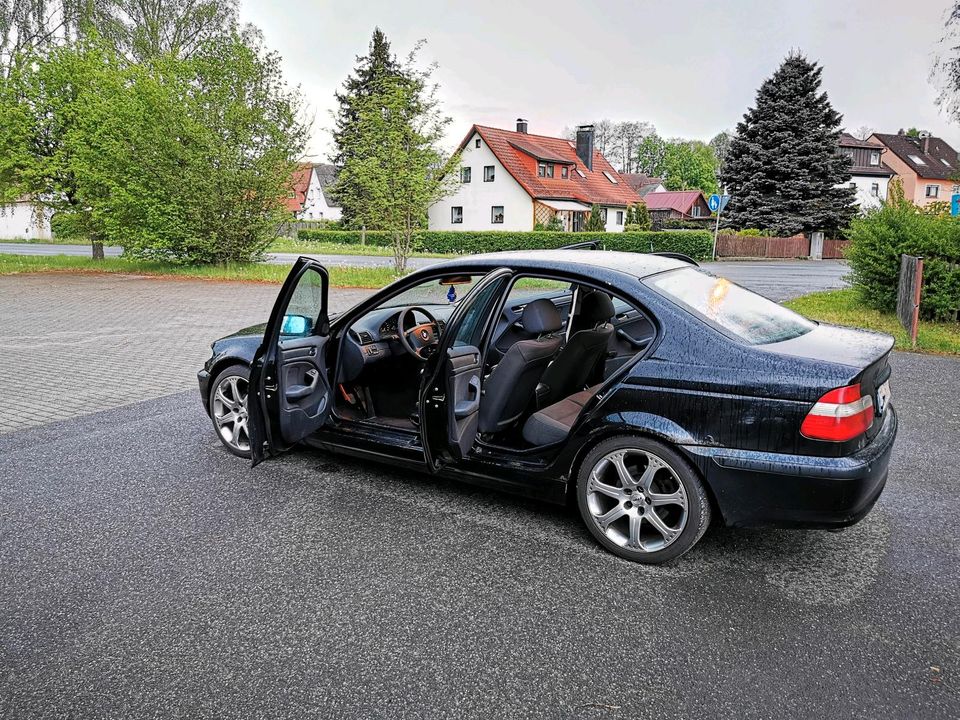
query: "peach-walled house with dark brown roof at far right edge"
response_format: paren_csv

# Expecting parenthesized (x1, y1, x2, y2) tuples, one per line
(869, 130, 960, 206)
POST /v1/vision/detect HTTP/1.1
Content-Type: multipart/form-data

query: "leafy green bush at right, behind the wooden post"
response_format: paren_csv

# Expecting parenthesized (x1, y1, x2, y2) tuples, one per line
(847, 192, 960, 321)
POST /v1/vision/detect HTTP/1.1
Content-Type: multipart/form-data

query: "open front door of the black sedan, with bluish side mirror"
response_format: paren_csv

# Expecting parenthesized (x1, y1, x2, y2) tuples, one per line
(248, 257, 333, 465)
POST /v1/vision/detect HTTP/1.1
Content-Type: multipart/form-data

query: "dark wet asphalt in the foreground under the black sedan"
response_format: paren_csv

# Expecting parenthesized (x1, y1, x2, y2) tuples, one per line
(0, 354, 960, 720)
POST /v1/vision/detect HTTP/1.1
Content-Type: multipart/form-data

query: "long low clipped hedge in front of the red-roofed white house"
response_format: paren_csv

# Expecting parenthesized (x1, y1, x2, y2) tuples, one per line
(298, 230, 713, 260)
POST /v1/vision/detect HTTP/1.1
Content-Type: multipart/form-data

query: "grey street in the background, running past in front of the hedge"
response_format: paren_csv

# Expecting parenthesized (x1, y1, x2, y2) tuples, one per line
(0, 243, 848, 302)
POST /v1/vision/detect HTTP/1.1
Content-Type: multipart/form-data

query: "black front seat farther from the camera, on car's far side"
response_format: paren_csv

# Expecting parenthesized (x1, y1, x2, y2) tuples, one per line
(537, 290, 616, 407)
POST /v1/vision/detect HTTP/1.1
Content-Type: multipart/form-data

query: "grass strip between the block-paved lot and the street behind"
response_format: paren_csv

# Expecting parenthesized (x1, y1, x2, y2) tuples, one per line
(0, 254, 396, 288)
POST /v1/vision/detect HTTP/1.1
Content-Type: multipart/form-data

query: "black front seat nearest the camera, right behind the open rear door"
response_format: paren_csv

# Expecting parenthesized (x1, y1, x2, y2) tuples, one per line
(479, 298, 563, 433)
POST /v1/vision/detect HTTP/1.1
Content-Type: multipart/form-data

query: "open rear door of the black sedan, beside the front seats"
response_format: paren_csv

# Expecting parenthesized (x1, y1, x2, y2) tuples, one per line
(420, 268, 512, 472)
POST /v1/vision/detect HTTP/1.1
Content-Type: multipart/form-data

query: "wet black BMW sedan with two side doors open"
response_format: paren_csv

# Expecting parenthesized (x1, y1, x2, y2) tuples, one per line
(199, 250, 897, 563)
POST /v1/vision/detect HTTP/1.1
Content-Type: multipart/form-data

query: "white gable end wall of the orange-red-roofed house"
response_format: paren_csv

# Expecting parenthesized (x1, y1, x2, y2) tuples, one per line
(428, 133, 533, 231)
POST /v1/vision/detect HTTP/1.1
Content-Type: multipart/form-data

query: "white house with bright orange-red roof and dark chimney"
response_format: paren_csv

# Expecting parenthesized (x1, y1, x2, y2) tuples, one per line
(429, 119, 642, 232)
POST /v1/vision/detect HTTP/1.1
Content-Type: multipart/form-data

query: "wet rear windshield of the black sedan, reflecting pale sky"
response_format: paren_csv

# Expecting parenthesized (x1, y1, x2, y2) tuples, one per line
(648, 268, 816, 345)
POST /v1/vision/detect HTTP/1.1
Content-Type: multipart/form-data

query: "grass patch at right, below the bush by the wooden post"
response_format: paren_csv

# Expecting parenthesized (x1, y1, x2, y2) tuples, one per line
(784, 289, 960, 355)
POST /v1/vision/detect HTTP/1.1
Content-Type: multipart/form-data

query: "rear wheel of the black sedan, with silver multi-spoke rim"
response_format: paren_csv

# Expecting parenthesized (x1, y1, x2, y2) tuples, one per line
(576, 435, 710, 565)
